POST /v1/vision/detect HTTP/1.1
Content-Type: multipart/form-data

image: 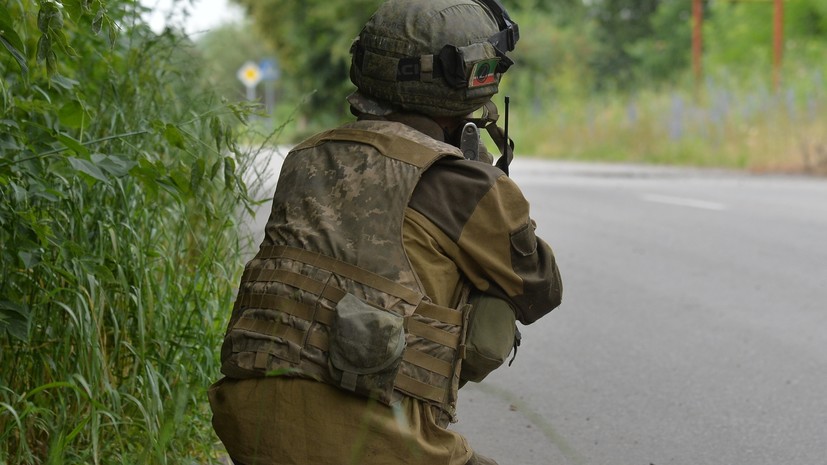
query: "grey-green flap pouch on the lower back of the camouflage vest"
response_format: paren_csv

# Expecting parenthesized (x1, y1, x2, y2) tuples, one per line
(329, 294, 405, 404)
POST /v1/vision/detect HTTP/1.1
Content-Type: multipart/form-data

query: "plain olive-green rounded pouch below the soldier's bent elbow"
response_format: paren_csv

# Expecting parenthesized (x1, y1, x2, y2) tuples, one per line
(460, 294, 519, 383)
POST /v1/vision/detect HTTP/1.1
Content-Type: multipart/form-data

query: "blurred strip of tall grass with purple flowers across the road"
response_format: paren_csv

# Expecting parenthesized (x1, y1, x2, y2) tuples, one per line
(509, 73, 827, 174)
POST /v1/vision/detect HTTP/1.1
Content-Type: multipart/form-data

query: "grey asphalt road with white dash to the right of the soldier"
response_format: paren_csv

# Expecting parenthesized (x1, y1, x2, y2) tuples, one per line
(453, 159, 827, 465)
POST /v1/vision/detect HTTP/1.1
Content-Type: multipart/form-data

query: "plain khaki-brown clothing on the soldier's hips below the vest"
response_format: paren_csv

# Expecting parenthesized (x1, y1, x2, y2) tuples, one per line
(213, 377, 497, 465)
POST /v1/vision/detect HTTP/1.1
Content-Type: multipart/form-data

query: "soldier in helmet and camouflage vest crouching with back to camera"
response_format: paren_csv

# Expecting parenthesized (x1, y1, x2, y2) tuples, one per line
(209, 0, 562, 465)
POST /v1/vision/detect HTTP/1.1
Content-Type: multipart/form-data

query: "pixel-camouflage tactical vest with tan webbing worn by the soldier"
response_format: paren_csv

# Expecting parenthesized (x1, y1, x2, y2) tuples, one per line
(222, 121, 467, 415)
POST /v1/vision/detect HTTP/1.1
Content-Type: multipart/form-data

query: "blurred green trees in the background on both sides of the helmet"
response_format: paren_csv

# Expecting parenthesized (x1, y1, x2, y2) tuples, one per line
(220, 0, 827, 134)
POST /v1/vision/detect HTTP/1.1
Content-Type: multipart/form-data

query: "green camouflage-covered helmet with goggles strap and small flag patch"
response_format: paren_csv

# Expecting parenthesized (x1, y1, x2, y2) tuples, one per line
(348, 0, 519, 116)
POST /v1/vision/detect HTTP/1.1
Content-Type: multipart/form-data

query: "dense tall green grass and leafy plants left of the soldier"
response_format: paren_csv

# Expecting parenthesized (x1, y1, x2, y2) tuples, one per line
(0, 0, 264, 464)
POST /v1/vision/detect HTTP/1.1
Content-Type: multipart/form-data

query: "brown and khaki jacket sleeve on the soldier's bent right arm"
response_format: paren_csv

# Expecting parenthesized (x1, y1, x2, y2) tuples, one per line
(410, 160, 562, 324)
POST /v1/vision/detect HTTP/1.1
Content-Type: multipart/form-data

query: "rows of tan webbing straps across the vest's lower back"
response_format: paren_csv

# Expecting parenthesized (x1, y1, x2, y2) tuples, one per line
(238, 246, 464, 405)
